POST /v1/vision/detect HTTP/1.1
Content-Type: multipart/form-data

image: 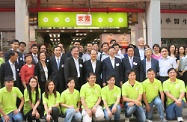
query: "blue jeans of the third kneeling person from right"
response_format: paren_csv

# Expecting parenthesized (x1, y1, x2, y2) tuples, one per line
(125, 103, 146, 122)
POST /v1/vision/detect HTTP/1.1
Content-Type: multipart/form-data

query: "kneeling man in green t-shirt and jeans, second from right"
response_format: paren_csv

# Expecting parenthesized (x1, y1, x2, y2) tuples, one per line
(142, 68, 167, 122)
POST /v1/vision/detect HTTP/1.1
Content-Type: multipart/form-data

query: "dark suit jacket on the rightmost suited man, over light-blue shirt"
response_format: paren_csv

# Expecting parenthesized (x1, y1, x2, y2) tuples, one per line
(142, 58, 159, 79)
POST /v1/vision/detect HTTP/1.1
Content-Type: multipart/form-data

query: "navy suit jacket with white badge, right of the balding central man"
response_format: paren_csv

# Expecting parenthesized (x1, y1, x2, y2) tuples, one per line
(102, 57, 122, 87)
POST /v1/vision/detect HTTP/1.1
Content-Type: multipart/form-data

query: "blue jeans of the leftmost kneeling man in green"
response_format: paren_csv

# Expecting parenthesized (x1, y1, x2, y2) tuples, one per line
(2, 112, 23, 122)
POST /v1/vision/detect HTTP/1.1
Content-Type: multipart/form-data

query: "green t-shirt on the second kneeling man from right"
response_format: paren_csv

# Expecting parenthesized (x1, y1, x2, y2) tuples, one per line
(142, 79, 163, 103)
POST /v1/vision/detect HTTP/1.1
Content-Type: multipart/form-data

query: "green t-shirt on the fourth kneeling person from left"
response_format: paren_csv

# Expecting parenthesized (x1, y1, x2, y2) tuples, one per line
(60, 89, 80, 113)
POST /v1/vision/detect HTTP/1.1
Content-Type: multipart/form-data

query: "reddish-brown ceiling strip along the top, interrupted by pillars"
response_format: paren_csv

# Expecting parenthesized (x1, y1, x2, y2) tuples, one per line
(0, 0, 187, 9)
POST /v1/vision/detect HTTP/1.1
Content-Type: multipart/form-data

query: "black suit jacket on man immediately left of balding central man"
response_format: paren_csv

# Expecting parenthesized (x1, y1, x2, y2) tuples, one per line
(64, 56, 84, 90)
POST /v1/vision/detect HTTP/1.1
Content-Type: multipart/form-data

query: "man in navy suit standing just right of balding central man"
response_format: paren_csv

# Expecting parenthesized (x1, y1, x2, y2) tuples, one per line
(102, 47, 123, 87)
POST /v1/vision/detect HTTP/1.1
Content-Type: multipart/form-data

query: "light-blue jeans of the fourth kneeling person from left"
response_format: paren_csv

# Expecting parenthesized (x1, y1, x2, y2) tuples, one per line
(64, 108, 82, 122)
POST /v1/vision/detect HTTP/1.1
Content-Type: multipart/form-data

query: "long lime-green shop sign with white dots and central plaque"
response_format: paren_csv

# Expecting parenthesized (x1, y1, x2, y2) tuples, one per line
(38, 12, 128, 28)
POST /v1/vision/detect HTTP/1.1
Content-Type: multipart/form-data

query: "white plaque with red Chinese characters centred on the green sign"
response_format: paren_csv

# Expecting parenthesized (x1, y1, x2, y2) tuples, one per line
(76, 14, 92, 26)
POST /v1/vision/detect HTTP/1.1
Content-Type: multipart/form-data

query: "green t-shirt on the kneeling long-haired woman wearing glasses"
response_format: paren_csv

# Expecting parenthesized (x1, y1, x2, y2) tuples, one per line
(23, 88, 41, 114)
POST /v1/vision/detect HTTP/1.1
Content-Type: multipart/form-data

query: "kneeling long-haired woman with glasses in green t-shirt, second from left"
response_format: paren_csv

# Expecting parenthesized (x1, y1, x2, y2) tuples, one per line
(23, 76, 42, 122)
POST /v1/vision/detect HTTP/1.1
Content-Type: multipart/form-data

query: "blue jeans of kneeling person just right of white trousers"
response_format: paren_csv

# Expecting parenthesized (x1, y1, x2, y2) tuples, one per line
(104, 105, 121, 122)
